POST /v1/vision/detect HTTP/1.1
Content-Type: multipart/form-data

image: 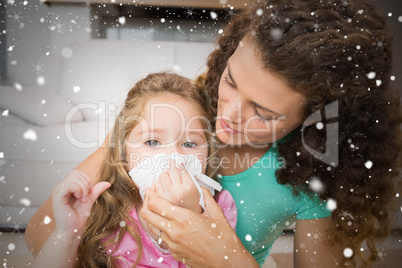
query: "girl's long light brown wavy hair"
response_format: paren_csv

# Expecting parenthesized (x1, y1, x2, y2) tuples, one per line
(77, 73, 216, 267)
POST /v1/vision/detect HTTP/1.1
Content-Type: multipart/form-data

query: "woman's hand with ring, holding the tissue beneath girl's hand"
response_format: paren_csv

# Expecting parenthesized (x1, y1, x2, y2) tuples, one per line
(140, 187, 259, 267)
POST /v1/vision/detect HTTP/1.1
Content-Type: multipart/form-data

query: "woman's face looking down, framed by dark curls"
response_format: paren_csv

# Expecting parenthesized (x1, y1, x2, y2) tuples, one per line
(216, 39, 307, 146)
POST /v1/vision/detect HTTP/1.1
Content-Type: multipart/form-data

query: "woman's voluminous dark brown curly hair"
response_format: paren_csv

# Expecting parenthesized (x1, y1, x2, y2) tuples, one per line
(198, 0, 402, 266)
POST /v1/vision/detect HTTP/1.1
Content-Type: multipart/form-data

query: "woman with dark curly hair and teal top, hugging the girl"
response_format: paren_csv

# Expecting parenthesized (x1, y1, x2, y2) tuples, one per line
(26, 0, 402, 267)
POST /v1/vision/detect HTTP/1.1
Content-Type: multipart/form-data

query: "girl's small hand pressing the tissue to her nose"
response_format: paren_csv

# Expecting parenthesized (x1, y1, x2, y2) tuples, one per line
(154, 161, 202, 213)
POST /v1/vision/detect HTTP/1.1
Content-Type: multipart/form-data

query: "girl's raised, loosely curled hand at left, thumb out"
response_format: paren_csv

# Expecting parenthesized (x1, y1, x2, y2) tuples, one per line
(52, 170, 110, 237)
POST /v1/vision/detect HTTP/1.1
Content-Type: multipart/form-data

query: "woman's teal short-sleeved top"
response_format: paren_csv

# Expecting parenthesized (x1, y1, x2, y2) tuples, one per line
(218, 144, 331, 266)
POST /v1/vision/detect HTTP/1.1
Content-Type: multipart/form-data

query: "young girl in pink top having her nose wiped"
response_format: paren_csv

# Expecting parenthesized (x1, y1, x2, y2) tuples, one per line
(34, 73, 237, 267)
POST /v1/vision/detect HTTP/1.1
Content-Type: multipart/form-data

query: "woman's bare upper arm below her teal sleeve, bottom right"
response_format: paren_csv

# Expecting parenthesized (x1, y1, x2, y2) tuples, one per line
(294, 217, 343, 268)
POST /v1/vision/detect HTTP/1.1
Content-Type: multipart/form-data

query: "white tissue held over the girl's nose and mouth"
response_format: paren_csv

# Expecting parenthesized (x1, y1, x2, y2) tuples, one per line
(128, 152, 222, 209)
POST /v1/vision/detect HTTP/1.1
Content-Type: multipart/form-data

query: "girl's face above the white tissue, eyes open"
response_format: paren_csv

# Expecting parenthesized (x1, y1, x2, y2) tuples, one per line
(125, 94, 208, 173)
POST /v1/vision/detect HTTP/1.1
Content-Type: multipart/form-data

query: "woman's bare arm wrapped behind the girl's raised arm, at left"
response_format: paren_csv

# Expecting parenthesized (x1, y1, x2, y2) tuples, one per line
(25, 146, 107, 257)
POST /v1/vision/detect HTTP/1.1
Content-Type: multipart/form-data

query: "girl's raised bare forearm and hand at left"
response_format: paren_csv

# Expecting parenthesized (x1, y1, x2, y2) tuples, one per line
(33, 171, 110, 268)
